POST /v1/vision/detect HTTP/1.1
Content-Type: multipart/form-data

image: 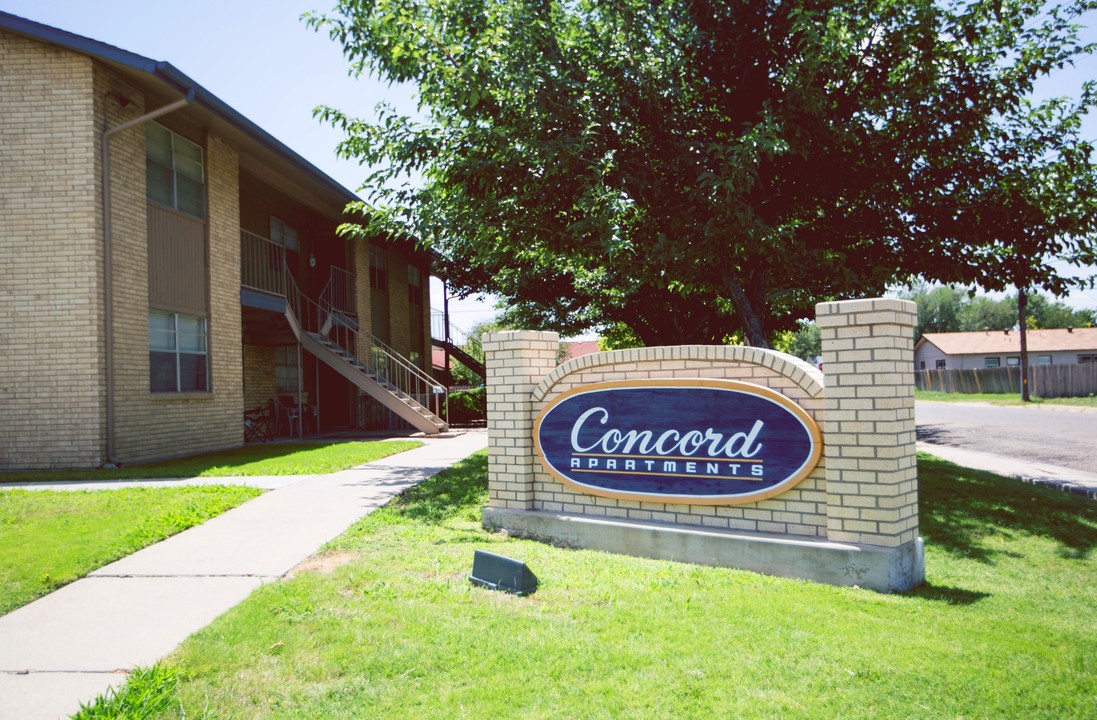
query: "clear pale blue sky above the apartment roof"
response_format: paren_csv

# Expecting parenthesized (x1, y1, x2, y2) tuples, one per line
(0, 0, 1097, 318)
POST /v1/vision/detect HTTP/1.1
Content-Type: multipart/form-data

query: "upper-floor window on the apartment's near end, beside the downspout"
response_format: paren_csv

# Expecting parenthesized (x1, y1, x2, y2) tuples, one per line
(145, 123, 205, 217)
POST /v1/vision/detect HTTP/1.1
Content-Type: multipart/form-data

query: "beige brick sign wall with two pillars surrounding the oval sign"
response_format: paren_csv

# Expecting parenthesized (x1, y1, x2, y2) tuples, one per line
(484, 307, 918, 548)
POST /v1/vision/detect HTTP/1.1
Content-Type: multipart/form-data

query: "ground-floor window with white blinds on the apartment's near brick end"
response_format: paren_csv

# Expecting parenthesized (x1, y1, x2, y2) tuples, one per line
(148, 310, 210, 393)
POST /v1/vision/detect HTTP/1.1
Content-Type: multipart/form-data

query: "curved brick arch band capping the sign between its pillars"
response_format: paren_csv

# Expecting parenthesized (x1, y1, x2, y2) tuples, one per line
(533, 345, 824, 402)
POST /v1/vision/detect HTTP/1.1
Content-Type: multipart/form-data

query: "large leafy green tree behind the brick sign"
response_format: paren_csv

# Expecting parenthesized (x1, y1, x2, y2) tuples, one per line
(309, 0, 1095, 346)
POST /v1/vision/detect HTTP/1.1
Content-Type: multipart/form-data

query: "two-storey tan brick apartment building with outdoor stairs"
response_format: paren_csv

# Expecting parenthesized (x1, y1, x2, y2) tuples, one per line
(0, 12, 445, 470)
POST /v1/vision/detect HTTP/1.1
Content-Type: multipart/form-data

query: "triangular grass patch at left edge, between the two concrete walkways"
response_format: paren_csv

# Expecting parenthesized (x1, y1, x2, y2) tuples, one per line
(0, 486, 260, 615)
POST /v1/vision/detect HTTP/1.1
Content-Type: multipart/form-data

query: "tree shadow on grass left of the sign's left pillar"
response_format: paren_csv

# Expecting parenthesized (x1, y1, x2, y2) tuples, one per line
(393, 452, 487, 522)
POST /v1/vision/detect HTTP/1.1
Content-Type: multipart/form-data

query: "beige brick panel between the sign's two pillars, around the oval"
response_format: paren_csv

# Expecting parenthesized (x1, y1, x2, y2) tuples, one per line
(522, 346, 827, 537)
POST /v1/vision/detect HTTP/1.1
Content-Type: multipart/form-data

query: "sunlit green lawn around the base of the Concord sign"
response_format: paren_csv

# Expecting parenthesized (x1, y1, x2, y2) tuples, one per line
(72, 454, 1097, 719)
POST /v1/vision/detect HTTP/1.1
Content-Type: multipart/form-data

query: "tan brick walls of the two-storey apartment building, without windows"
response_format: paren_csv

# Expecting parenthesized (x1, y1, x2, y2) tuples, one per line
(0, 22, 429, 471)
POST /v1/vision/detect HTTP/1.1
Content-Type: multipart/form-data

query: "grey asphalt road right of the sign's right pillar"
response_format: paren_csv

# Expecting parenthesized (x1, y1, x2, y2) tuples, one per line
(915, 402, 1097, 472)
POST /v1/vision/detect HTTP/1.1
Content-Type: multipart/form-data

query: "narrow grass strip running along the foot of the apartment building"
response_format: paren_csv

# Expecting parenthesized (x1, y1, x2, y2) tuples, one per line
(0, 440, 422, 483)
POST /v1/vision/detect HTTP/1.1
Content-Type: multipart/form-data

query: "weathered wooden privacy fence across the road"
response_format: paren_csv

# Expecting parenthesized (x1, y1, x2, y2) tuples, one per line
(914, 363, 1097, 397)
